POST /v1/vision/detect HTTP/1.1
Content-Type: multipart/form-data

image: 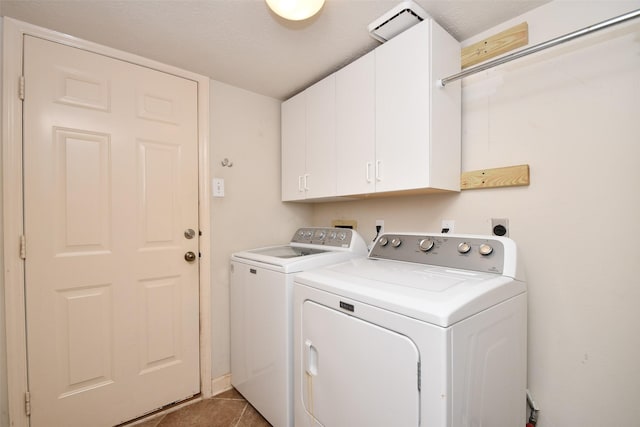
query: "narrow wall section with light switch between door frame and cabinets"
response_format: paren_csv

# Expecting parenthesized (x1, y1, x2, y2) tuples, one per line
(211, 81, 311, 379)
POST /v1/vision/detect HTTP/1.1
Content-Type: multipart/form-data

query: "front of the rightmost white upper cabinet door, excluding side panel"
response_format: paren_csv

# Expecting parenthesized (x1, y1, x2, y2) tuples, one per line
(375, 20, 435, 192)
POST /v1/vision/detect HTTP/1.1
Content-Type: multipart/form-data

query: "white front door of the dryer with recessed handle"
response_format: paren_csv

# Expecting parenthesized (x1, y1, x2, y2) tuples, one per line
(302, 300, 420, 427)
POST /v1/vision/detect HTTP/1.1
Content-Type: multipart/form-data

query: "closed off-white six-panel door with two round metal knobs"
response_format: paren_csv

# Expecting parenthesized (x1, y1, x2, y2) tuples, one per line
(24, 36, 200, 427)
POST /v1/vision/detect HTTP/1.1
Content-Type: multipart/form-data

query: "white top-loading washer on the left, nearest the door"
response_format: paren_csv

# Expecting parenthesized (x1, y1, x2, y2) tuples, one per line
(230, 231, 367, 427)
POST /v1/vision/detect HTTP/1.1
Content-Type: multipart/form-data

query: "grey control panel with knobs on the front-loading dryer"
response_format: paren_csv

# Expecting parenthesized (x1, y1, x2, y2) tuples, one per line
(369, 233, 504, 274)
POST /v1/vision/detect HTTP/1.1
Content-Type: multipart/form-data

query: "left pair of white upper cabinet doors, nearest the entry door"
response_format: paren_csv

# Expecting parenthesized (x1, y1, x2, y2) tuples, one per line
(282, 75, 336, 201)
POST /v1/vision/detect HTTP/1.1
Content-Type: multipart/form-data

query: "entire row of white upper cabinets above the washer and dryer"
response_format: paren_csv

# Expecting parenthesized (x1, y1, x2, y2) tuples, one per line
(282, 19, 461, 200)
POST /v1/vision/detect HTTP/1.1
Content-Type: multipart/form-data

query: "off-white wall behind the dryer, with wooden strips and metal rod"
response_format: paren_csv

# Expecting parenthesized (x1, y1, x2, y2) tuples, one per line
(314, 1, 640, 427)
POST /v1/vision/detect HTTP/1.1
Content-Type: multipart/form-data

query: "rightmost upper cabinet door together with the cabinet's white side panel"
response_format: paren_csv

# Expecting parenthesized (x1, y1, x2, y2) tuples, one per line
(375, 20, 461, 192)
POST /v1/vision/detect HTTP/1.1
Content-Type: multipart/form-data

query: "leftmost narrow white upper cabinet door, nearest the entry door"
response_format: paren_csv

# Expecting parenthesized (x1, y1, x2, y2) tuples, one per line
(281, 92, 306, 201)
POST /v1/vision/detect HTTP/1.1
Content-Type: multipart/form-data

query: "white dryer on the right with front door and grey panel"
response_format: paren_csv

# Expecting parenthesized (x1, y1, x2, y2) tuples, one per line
(294, 233, 527, 427)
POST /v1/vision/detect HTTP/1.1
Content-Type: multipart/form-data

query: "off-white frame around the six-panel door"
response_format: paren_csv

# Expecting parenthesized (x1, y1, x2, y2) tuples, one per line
(1, 17, 213, 427)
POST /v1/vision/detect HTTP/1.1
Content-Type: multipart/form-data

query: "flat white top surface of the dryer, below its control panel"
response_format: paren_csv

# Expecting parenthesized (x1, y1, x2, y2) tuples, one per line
(295, 258, 526, 327)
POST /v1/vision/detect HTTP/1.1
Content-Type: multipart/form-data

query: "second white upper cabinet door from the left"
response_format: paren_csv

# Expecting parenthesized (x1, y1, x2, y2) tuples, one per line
(303, 74, 336, 198)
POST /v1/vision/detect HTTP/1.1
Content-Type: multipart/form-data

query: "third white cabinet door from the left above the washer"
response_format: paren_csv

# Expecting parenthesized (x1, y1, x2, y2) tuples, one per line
(336, 52, 375, 196)
